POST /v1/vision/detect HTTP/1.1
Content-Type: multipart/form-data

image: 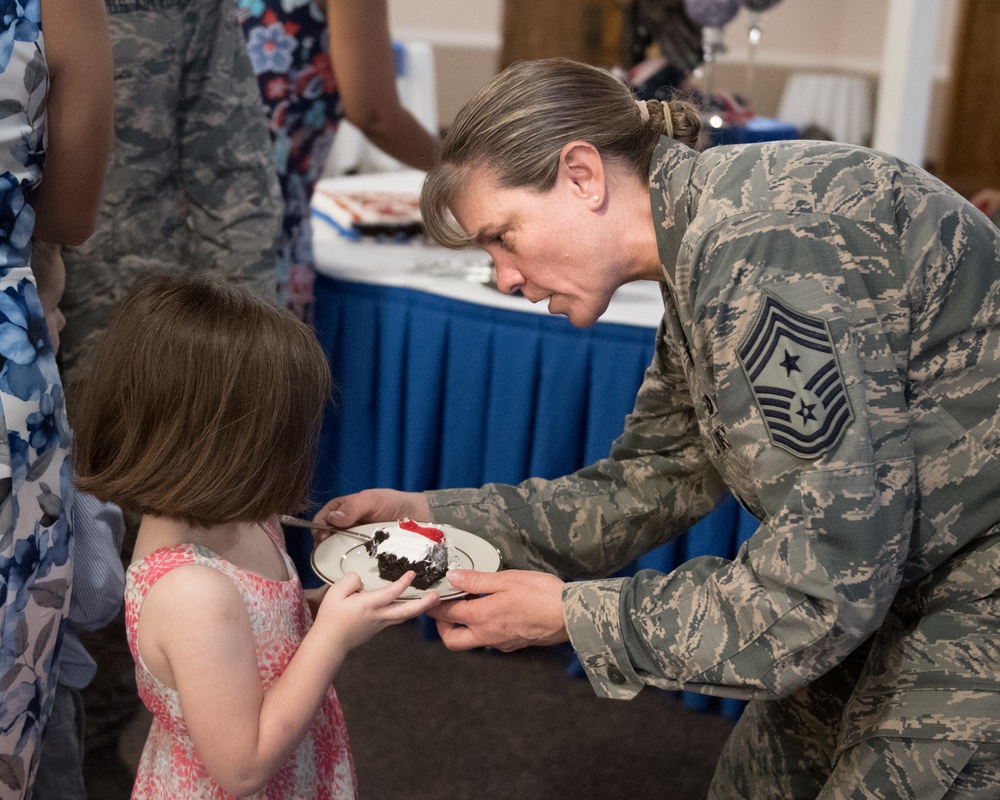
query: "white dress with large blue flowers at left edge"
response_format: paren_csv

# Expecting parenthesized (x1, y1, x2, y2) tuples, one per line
(0, 0, 72, 800)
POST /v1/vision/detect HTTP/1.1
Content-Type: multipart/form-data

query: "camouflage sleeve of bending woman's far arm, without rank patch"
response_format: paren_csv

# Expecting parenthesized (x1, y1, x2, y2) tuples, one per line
(427, 316, 725, 578)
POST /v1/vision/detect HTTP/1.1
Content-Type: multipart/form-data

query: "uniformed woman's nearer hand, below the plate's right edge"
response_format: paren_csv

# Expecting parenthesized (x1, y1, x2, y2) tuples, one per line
(428, 569, 569, 652)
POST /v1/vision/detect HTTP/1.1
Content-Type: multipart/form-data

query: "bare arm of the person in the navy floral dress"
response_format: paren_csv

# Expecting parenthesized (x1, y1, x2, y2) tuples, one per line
(326, 0, 437, 169)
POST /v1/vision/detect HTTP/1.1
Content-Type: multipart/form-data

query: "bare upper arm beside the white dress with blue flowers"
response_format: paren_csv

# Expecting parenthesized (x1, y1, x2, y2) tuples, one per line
(34, 0, 114, 245)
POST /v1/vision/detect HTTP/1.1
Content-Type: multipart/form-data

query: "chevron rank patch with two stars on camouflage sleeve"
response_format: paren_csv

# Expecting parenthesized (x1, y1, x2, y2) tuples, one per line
(738, 294, 854, 459)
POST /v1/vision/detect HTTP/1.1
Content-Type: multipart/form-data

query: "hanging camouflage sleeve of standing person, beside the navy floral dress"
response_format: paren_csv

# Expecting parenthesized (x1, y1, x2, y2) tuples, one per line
(178, 2, 283, 295)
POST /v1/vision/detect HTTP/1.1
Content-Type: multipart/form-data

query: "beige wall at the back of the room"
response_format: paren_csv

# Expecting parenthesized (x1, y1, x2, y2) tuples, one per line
(389, 0, 958, 160)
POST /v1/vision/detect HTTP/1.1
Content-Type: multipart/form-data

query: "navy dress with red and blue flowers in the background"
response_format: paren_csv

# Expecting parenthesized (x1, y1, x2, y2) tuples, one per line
(236, 0, 343, 322)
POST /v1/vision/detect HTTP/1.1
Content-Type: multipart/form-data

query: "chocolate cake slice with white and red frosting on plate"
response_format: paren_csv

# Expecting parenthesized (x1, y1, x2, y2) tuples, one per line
(365, 519, 448, 589)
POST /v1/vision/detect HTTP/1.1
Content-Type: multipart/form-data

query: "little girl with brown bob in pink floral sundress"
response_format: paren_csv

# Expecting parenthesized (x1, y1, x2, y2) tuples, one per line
(75, 276, 438, 800)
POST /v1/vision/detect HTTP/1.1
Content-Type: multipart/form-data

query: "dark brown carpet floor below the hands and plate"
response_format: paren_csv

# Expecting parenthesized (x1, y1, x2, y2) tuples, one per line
(107, 622, 733, 800)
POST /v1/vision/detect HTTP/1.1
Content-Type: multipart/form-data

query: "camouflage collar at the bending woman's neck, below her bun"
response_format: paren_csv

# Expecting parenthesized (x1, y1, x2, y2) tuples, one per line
(649, 136, 698, 286)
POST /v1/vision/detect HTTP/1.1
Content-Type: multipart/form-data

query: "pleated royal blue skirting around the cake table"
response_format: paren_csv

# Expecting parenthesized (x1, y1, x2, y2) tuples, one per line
(308, 275, 756, 713)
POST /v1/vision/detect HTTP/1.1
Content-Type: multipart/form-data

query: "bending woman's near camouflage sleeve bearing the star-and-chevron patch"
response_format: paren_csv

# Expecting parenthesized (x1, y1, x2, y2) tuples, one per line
(563, 205, 915, 697)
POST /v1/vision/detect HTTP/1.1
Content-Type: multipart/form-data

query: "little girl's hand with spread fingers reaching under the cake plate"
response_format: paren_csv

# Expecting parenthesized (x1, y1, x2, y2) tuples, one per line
(310, 571, 441, 654)
